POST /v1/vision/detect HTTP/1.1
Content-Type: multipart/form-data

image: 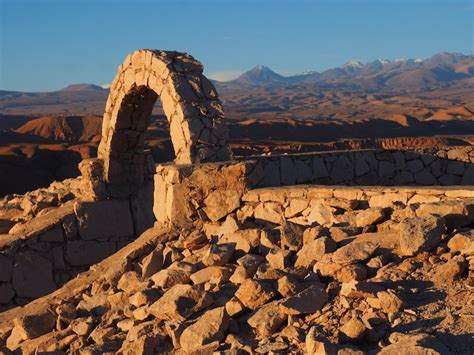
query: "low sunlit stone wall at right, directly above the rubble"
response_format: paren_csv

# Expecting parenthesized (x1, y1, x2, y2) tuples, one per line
(239, 185, 474, 228)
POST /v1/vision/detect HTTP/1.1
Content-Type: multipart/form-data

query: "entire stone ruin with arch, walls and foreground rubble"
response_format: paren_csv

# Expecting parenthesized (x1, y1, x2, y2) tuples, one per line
(0, 50, 474, 355)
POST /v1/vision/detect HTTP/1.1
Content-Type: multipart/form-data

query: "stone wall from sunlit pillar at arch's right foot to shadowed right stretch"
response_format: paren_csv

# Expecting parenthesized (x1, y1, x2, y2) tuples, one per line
(154, 147, 474, 226)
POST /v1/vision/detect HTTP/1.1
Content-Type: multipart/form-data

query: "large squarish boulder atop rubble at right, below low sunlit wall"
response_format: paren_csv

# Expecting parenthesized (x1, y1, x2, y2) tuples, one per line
(399, 215, 444, 255)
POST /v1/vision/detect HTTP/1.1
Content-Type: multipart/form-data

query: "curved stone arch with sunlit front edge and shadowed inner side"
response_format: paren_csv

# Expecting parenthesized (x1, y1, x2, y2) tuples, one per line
(98, 49, 232, 195)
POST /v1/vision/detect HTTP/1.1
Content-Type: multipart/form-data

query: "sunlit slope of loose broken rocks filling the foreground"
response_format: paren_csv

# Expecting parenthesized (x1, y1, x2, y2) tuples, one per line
(0, 195, 474, 354)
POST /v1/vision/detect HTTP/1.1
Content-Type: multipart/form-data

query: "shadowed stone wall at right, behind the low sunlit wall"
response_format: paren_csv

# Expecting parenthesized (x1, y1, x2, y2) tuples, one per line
(248, 146, 474, 187)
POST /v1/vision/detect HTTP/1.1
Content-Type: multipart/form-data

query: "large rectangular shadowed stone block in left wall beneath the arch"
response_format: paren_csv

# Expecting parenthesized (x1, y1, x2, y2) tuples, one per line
(74, 199, 134, 241)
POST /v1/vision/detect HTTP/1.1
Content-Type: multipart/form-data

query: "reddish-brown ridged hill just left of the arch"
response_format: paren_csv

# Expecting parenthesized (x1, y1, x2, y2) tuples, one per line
(15, 116, 102, 142)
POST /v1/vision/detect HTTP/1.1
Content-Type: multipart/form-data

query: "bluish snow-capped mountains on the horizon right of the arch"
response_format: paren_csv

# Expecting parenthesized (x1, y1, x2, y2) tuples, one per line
(223, 52, 474, 89)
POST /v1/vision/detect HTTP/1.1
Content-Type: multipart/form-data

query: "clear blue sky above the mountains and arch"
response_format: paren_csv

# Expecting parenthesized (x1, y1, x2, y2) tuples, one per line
(0, 0, 474, 91)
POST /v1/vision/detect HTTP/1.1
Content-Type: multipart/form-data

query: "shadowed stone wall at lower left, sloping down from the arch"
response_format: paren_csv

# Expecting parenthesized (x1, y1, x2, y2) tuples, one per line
(0, 199, 136, 311)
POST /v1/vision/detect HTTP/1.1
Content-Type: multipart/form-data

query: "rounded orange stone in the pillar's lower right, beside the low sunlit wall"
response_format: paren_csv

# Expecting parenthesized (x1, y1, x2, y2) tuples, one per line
(203, 190, 242, 221)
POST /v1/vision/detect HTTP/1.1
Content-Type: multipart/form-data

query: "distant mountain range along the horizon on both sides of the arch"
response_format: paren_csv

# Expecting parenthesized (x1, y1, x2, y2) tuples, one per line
(0, 52, 474, 115)
